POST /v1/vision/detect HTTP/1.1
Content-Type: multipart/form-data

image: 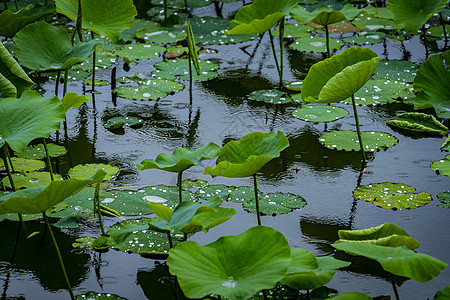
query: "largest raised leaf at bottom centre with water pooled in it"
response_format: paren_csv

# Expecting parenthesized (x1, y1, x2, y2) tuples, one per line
(167, 226, 291, 299)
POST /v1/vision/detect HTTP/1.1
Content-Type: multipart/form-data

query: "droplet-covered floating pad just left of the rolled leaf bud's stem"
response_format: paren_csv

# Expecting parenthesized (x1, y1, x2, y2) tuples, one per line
(114, 79, 184, 100)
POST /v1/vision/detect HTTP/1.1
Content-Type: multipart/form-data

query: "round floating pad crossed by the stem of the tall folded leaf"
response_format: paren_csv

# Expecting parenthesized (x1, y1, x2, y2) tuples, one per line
(319, 130, 398, 152)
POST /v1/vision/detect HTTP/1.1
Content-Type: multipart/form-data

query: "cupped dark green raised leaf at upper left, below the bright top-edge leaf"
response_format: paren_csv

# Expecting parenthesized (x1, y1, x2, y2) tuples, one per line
(13, 22, 97, 71)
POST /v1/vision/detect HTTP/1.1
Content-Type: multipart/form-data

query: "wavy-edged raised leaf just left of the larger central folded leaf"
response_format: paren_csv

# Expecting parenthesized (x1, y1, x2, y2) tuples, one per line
(137, 142, 220, 173)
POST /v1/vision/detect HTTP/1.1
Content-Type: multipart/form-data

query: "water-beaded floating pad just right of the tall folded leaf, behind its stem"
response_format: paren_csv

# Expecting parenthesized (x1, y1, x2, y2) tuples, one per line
(342, 79, 413, 106)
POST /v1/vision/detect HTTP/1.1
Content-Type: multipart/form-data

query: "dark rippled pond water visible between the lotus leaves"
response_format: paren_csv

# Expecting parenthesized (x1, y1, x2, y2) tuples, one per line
(0, 1, 450, 300)
